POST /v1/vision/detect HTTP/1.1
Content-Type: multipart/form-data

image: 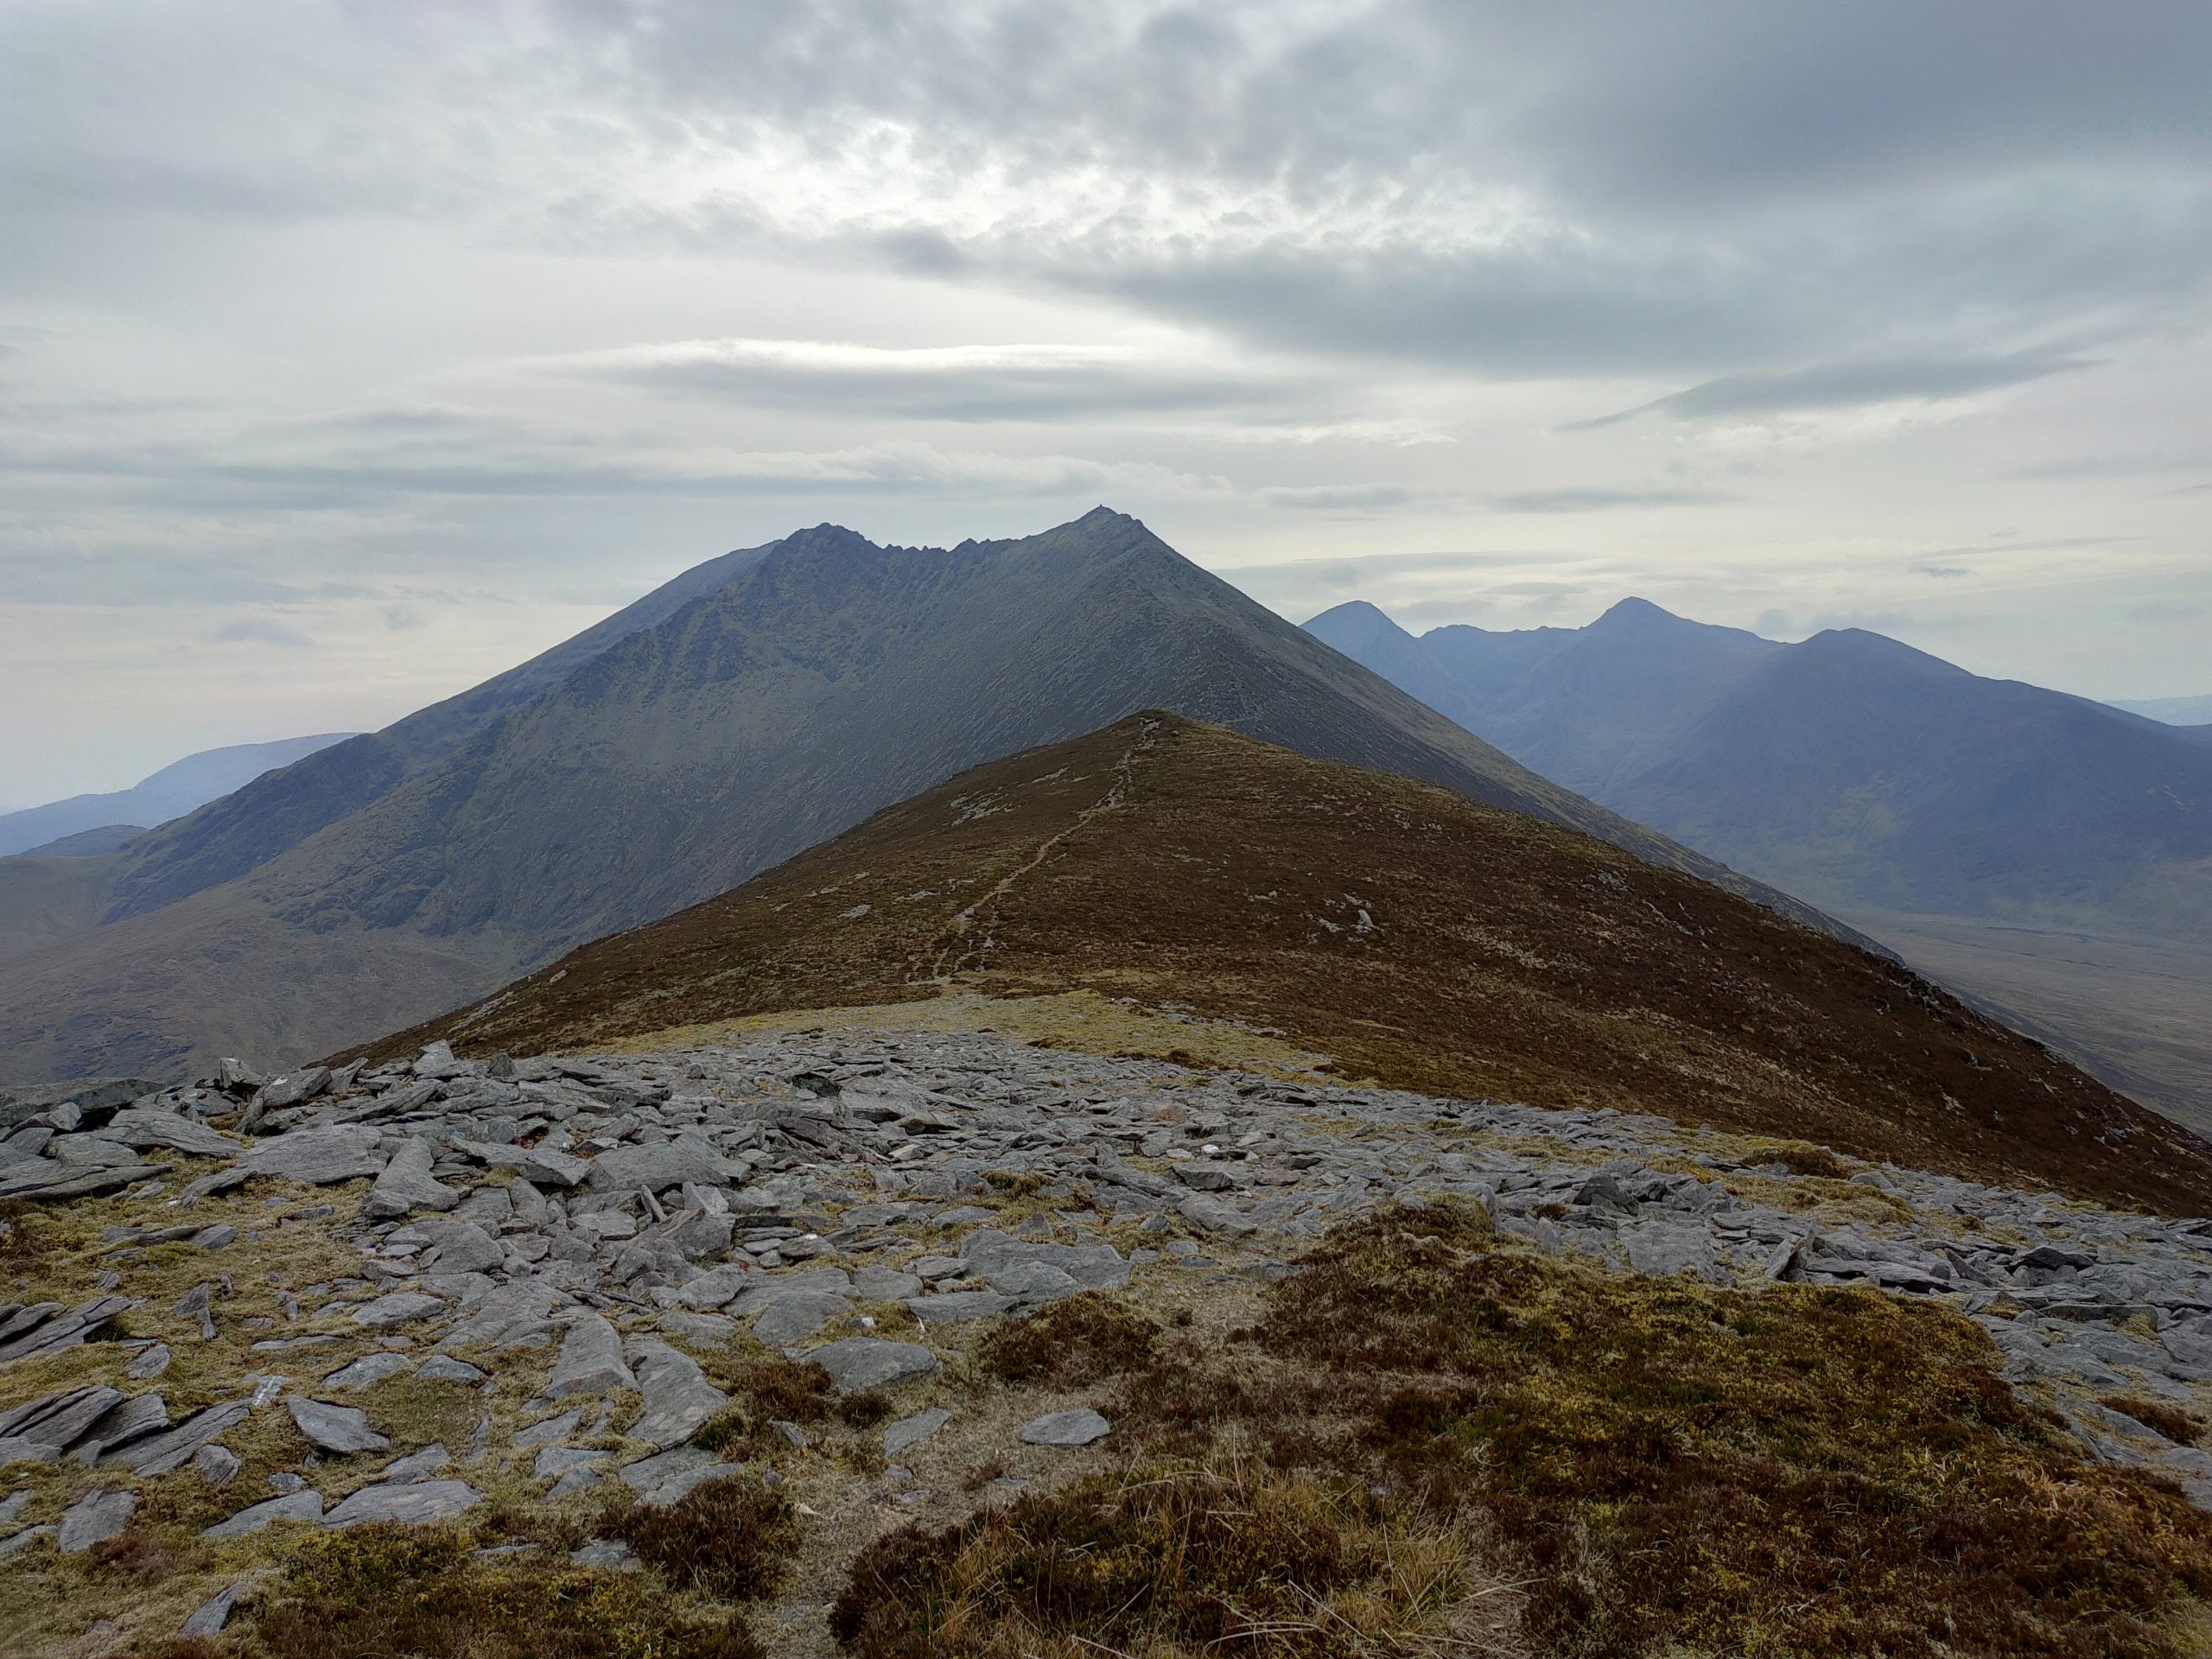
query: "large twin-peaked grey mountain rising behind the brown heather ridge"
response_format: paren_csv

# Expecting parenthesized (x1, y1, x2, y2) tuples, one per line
(0, 509, 1814, 1077)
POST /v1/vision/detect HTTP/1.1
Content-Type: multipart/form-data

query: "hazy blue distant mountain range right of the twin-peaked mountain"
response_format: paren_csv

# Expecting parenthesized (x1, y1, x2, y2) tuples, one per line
(1307, 600, 2212, 1122)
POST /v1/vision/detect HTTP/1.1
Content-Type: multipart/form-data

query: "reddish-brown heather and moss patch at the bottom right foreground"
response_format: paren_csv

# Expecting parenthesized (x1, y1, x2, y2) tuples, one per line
(823, 1208, 2212, 1659)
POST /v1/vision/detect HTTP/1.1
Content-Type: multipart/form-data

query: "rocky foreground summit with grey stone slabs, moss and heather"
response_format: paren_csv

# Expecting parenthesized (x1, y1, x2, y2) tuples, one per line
(0, 1004, 2212, 1655)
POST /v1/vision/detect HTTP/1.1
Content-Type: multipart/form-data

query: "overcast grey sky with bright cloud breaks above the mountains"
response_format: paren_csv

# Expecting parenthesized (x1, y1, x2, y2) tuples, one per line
(0, 0, 2212, 807)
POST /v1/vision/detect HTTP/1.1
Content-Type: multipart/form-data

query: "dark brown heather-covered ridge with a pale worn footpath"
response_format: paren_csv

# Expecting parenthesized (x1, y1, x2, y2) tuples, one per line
(374, 715, 2212, 1214)
